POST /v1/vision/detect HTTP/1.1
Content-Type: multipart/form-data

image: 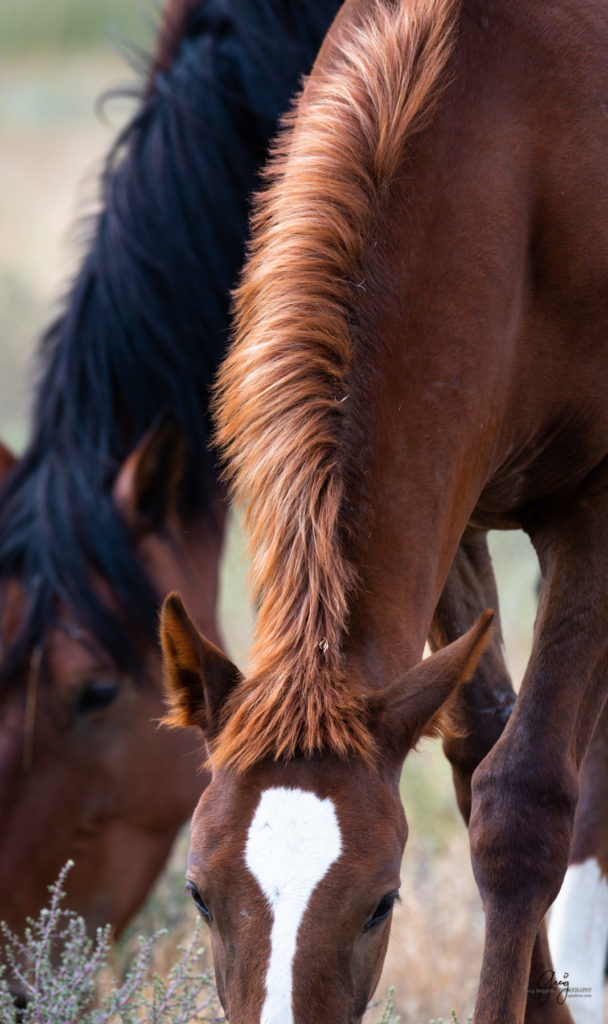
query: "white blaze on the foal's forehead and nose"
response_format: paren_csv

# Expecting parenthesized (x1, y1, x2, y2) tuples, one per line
(245, 787, 342, 1024)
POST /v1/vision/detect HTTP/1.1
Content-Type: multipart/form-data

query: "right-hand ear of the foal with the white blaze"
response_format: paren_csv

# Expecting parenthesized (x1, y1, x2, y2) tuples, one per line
(370, 609, 493, 762)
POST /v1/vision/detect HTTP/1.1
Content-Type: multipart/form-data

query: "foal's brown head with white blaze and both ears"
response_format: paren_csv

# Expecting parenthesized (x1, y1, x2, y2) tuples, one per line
(162, 595, 492, 1024)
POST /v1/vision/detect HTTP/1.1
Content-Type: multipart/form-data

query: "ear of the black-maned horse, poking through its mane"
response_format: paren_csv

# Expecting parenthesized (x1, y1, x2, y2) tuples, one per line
(112, 416, 187, 536)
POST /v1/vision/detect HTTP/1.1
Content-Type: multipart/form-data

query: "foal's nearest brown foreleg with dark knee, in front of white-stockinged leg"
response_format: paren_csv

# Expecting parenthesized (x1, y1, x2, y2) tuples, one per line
(470, 480, 608, 1024)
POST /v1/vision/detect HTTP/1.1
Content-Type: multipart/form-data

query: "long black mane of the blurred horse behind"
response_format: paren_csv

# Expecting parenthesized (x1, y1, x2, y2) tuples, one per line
(0, 0, 339, 680)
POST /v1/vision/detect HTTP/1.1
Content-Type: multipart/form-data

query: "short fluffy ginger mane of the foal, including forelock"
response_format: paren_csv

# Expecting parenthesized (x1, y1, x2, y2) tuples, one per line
(213, 0, 458, 770)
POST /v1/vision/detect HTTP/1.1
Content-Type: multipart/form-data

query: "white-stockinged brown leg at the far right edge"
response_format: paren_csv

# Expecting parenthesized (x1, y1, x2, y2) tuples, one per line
(549, 705, 608, 1024)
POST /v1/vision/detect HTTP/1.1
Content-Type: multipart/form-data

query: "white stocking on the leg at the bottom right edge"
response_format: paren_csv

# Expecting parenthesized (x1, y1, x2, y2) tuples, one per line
(549, 858, 608, 1024)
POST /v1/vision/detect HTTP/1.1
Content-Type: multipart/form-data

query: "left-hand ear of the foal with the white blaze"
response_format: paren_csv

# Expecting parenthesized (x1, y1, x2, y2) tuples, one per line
(161, 594, 242, 740)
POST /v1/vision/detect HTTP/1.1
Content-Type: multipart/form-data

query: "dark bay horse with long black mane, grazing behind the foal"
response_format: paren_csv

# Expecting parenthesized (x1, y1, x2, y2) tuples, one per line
(0, 0, 338, 931)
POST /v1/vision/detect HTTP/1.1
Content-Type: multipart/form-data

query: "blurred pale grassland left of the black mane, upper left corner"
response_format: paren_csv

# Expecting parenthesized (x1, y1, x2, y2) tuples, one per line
(0, 0, 152, 449)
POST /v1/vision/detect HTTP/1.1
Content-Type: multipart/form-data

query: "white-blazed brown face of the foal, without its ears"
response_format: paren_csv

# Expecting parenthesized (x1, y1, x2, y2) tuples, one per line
(183, 756, 406, 1024)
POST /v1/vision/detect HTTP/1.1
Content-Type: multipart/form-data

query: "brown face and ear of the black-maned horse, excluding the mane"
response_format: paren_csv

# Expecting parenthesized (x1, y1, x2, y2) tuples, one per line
(0, 424, 222, 931)
